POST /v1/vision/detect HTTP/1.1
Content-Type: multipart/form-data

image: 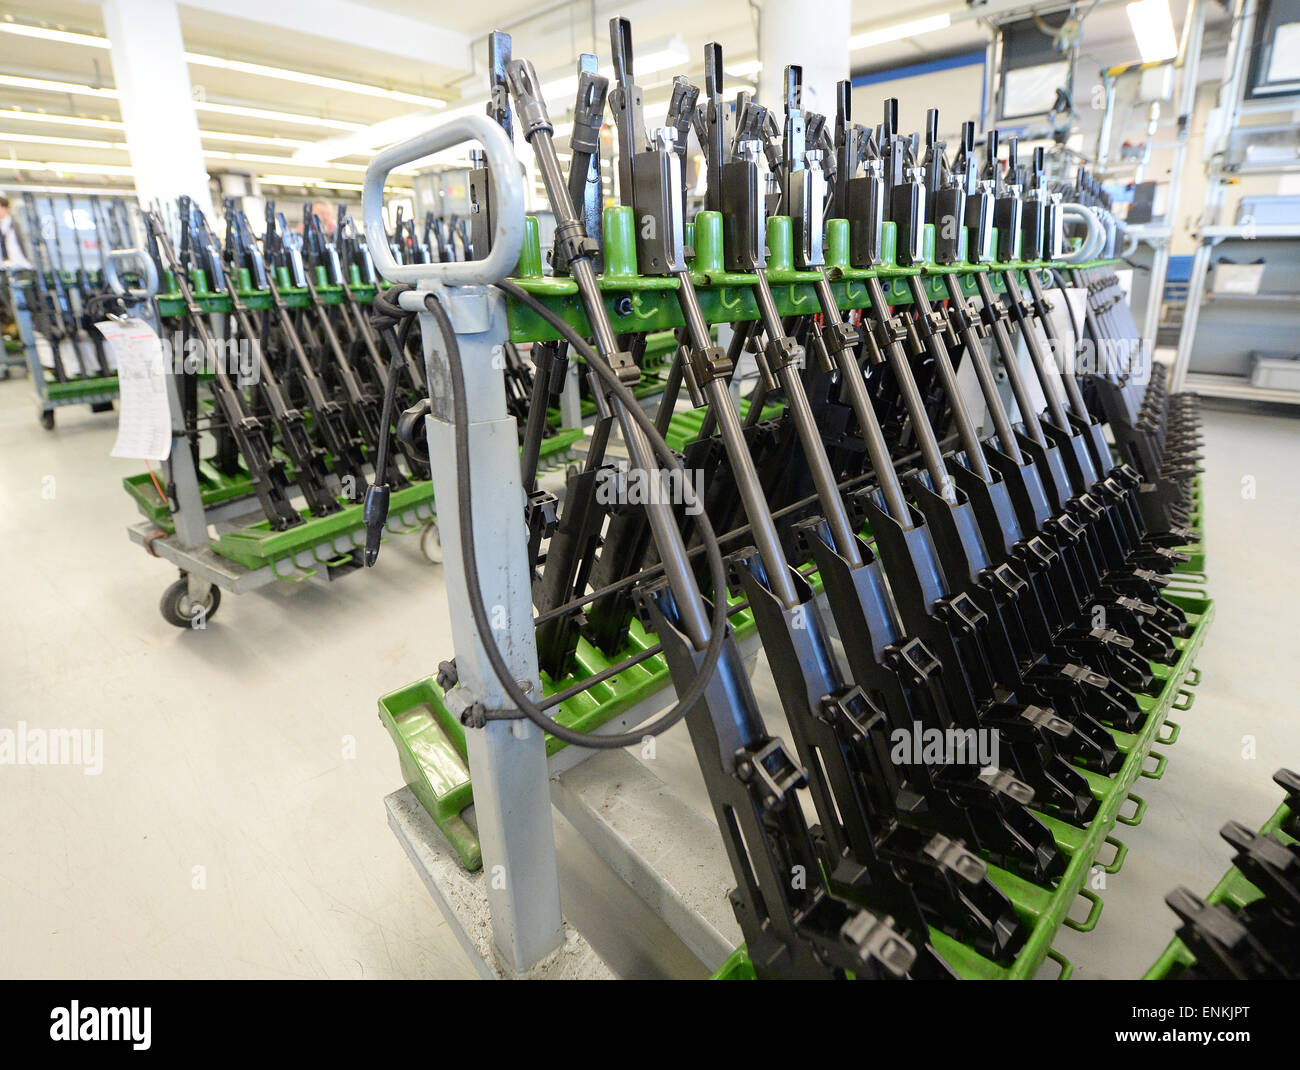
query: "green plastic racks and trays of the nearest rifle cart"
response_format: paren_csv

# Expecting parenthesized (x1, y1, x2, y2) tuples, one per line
(378, 205, 1185, 979)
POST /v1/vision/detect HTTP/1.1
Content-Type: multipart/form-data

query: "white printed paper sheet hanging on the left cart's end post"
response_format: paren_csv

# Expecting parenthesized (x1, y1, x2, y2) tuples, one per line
(95, 320, 172, 460)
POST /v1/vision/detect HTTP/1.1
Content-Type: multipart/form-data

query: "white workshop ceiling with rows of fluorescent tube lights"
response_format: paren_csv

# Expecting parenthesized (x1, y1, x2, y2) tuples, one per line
(0, 0, 1222, 200)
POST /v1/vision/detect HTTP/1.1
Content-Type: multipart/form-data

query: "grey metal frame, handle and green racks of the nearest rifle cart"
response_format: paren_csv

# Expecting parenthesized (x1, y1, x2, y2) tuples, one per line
(364, 108, 1213, 976)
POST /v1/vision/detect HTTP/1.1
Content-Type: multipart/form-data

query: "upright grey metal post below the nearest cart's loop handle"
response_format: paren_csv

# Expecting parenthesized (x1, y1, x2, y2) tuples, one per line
(420, 286, 563, 974)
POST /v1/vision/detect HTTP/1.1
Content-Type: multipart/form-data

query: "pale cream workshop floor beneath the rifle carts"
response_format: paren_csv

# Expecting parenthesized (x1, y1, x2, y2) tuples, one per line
(0, 376, 1300, 978)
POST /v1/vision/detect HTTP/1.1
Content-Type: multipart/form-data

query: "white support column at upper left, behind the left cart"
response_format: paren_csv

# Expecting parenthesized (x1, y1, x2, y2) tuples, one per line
(104, 0, 212, 217)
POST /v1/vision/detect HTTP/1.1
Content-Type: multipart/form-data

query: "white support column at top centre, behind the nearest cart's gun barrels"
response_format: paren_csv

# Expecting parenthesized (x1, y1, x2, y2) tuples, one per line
(758, 0, 853, 120)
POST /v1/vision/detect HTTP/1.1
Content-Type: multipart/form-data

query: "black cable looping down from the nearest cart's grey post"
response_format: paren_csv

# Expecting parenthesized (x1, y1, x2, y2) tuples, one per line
(425, 281, 727, 750)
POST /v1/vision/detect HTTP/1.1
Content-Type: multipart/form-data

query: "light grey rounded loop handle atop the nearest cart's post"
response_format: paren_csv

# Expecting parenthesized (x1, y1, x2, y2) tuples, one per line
(361, 116, 524, 286)
